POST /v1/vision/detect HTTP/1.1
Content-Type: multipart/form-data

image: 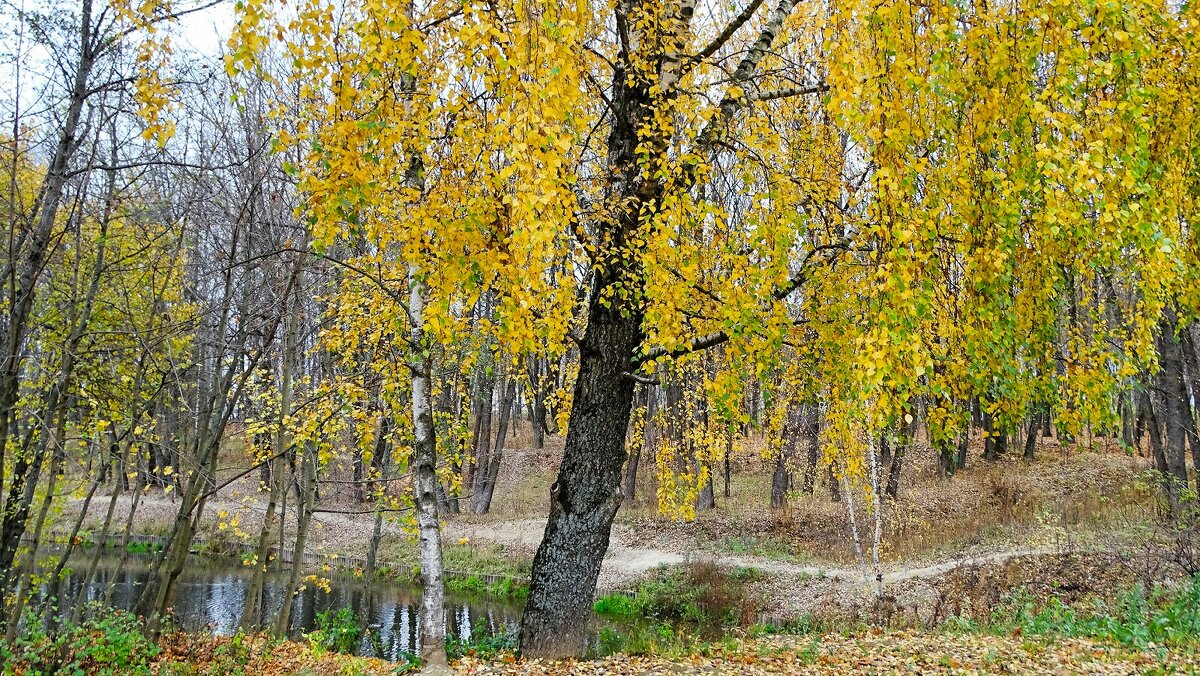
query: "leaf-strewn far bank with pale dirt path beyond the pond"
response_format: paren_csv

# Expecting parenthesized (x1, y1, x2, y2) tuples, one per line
(54, 427, 1181, 627)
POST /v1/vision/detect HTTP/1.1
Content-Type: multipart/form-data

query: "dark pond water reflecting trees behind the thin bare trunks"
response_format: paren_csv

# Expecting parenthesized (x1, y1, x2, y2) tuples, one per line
(43, 552, 521, 660)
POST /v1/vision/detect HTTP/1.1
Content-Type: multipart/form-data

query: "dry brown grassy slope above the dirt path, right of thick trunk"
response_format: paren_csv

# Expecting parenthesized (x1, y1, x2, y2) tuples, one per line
(609, 432, 1157, 564)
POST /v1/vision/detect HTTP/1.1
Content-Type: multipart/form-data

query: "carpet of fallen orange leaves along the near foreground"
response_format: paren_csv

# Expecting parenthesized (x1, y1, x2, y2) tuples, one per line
(136, 632, 1200, 676)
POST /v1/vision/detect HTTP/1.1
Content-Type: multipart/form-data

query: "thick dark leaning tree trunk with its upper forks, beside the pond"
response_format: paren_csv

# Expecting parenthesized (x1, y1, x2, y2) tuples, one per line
(521, 0, 797, 657)
